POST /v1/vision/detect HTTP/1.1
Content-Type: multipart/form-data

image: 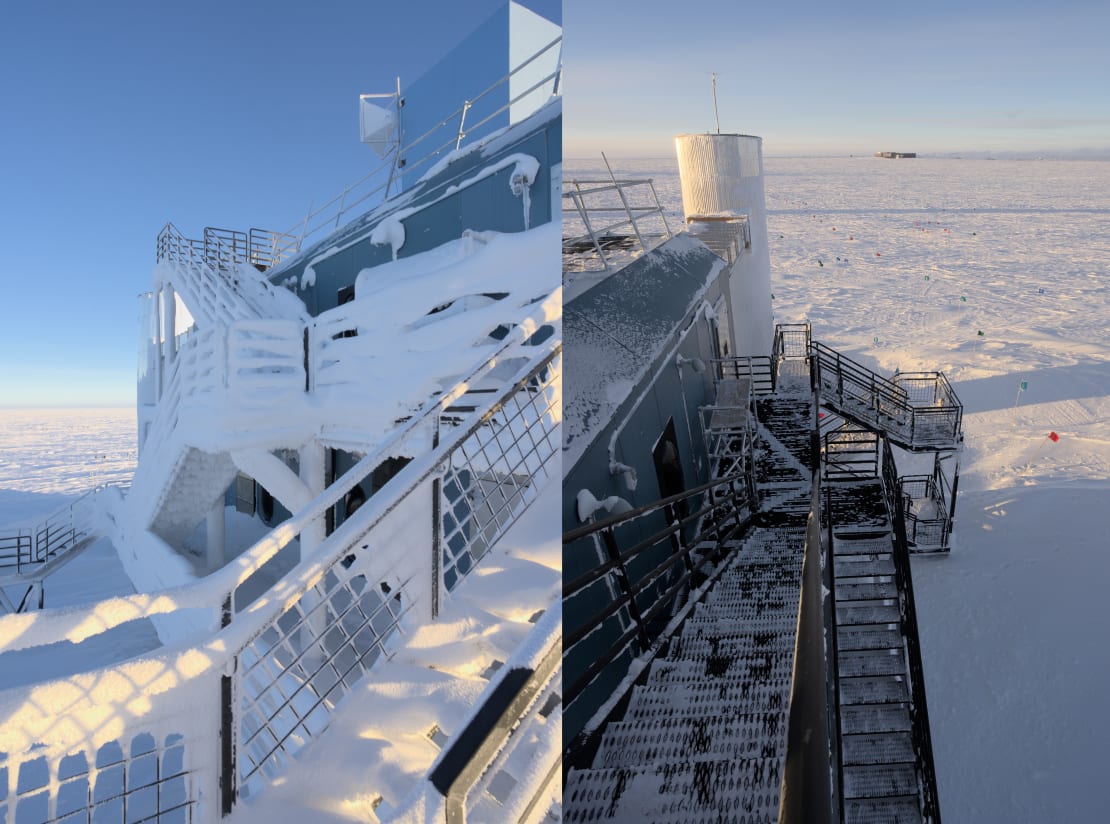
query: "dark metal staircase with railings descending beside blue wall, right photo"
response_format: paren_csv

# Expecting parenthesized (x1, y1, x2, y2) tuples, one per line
(564, 328, 960, 823)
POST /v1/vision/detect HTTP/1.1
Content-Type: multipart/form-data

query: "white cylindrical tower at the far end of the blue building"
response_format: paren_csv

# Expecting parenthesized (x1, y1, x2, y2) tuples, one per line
(675, 134, 774, 355)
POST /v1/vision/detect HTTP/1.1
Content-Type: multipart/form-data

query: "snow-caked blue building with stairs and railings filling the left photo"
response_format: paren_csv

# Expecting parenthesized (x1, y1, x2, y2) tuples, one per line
(0, 2, 562, 824)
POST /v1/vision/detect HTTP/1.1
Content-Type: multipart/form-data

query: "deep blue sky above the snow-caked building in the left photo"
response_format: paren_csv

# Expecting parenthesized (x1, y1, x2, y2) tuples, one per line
(0, 0, 558, 406)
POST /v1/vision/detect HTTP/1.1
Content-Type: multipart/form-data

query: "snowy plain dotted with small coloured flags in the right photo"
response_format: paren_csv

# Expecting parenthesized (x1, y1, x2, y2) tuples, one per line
(566, 157, 1110, 823)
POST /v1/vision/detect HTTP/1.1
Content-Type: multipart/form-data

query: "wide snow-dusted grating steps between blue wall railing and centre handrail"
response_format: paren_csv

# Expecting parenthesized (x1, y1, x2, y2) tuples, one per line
(564, 365, 815, 824)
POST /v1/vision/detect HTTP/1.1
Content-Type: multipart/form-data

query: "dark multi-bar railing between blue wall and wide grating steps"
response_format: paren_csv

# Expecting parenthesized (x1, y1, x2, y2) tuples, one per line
(563, 474, 754, 724)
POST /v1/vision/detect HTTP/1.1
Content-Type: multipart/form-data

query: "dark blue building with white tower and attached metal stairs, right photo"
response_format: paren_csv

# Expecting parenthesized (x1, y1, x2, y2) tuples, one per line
(563, 134, 961, 822)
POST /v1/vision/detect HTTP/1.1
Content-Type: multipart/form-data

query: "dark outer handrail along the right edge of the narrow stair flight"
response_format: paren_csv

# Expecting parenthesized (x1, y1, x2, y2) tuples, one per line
(880, 435, 940, 824)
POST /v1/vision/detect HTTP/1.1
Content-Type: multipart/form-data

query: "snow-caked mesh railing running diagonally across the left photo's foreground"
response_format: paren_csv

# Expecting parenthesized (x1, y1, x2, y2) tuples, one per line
(0, 342, 562, 821)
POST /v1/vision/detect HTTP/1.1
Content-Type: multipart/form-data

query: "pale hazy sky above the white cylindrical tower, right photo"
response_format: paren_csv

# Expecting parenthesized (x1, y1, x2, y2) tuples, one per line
(564, 0, 1110, 158)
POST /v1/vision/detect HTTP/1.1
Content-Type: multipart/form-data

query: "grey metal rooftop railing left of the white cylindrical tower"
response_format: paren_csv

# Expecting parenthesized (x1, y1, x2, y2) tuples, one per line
(563, 178, 672, 272)
